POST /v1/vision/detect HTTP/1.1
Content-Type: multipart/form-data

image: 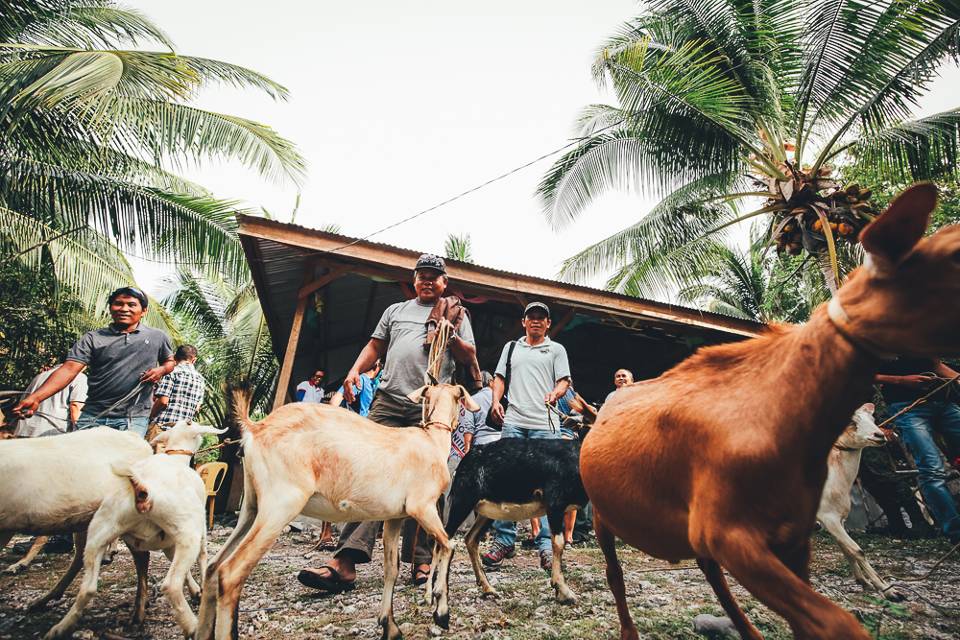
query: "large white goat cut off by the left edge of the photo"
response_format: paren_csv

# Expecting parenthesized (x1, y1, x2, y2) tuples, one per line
(0, 427, 153, 608)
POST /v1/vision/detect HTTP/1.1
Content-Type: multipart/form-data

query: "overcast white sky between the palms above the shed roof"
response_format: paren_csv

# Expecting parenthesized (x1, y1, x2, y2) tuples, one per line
(124, 0, 960, 296)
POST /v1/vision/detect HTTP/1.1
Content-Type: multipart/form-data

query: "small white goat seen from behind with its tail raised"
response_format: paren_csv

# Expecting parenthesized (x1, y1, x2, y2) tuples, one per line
(44, 421, 225, 640)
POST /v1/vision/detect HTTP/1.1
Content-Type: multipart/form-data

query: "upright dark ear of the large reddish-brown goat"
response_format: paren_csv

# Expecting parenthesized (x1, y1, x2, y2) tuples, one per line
(860, 182, 937, 269)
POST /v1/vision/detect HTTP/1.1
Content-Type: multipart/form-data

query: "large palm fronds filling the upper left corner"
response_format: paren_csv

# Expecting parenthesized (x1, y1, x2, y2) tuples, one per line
(0, 0, 303, 316)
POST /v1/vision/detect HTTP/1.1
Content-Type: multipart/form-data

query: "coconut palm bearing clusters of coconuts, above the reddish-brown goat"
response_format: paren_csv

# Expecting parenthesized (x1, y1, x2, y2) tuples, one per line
(539, 0, 960, 296)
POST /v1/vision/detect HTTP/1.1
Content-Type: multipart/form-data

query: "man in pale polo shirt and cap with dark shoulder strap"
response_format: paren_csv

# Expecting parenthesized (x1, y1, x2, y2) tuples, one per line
(483, 302, 570, 572)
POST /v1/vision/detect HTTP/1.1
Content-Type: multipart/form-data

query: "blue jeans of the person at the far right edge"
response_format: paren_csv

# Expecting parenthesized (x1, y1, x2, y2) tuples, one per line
(890, 400, 960, 538)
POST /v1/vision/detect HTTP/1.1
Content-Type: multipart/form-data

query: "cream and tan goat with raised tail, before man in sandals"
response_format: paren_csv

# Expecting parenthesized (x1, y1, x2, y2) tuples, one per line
(197, 384, 479, 640)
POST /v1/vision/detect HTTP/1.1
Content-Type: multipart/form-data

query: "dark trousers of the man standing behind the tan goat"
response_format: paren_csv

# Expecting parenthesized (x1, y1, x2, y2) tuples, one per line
(334, 393, 433, 564)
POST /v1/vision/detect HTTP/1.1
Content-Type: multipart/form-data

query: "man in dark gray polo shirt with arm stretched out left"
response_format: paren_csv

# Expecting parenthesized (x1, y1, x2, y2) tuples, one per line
(13, 287, 175, 435)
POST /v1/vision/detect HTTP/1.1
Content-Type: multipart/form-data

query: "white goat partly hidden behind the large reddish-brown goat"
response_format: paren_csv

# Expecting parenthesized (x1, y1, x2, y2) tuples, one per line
(817, 403, 903, 600)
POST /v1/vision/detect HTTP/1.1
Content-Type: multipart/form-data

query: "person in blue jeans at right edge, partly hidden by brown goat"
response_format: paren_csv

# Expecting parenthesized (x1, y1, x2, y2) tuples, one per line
(876, 356, 960, 544)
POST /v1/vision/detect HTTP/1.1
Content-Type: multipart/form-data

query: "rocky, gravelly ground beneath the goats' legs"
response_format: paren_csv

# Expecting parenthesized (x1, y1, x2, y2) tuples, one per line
(0, 527, 960, 640)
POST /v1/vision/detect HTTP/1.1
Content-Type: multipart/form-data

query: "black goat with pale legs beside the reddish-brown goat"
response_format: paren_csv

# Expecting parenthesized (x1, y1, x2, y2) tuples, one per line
(430, 438, 587, 629)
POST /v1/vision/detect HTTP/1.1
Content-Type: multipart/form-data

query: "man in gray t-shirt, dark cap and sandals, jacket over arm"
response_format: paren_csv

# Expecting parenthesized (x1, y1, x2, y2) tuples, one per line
(297, 254, 480, 592)
